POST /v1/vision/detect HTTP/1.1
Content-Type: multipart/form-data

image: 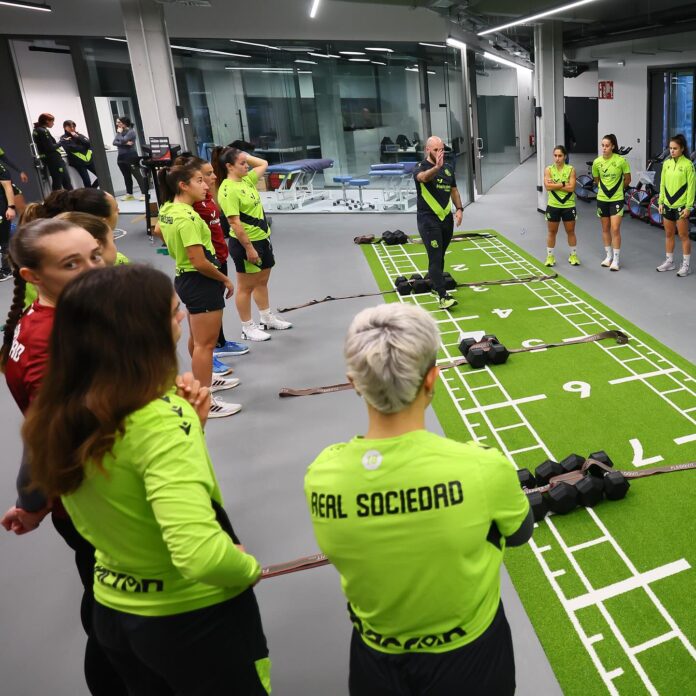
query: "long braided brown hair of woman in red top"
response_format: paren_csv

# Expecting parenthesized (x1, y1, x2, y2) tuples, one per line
(0, 218, 75, 372)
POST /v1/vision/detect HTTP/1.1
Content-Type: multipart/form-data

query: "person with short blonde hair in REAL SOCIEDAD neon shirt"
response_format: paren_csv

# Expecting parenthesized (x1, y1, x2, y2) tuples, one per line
(305, 303, 534, 696)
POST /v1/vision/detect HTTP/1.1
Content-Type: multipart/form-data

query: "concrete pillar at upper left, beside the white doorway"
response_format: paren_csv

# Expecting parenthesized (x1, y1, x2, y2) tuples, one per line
(120, 0, 186, 150)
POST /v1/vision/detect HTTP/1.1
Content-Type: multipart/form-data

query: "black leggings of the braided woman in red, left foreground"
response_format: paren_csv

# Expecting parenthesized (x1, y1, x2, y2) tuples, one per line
(51, 515, 128, 696)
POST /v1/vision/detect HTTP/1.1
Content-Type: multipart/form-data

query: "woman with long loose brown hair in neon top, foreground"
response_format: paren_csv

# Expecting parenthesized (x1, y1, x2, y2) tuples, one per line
(23, 265, 270, 696)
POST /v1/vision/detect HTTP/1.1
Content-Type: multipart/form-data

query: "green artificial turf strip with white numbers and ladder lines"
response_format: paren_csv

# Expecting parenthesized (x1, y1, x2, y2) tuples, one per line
(363, 230, 696, 696)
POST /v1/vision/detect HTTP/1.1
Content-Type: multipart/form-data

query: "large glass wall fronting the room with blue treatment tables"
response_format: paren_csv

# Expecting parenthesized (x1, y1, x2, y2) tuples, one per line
(173, 39, 470, 209)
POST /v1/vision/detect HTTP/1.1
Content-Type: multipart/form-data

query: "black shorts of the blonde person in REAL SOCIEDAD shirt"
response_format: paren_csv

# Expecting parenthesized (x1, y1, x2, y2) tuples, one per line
(348, 603, 515, 696)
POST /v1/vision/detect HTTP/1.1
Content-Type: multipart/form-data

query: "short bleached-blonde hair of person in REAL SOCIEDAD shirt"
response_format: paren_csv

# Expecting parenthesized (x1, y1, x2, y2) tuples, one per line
(343, 303, 440, 414)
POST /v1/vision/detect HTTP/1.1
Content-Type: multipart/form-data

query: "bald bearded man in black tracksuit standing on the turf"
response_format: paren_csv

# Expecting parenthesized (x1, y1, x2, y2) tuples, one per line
(413, 135, 463, 309)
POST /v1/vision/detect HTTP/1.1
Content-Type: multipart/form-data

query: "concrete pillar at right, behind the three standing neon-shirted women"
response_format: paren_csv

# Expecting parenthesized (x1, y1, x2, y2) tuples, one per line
(534, 21, 564, 210)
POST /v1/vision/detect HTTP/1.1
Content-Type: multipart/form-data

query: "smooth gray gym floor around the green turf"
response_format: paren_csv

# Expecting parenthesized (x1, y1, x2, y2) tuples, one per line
(0, 155, 696, 696)
